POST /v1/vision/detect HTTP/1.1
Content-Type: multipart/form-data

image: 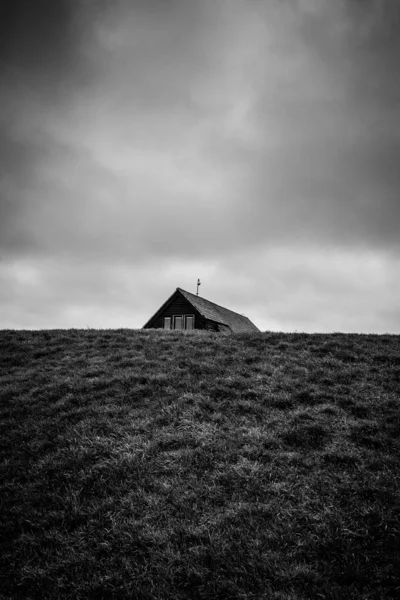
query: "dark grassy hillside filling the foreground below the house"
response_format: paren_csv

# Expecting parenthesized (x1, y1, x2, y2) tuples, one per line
(0, 330, 400, 600)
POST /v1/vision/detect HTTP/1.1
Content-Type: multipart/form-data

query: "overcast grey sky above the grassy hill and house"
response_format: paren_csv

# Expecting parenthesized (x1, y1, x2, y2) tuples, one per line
(0, 0, 400, 333)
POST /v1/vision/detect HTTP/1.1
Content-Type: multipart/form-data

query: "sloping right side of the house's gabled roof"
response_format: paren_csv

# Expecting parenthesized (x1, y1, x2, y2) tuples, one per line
(176, 288, 260, 333)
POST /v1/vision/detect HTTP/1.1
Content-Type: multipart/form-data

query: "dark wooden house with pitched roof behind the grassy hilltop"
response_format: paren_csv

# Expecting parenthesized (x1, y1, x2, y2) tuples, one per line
(143, 288, 260, 333)
